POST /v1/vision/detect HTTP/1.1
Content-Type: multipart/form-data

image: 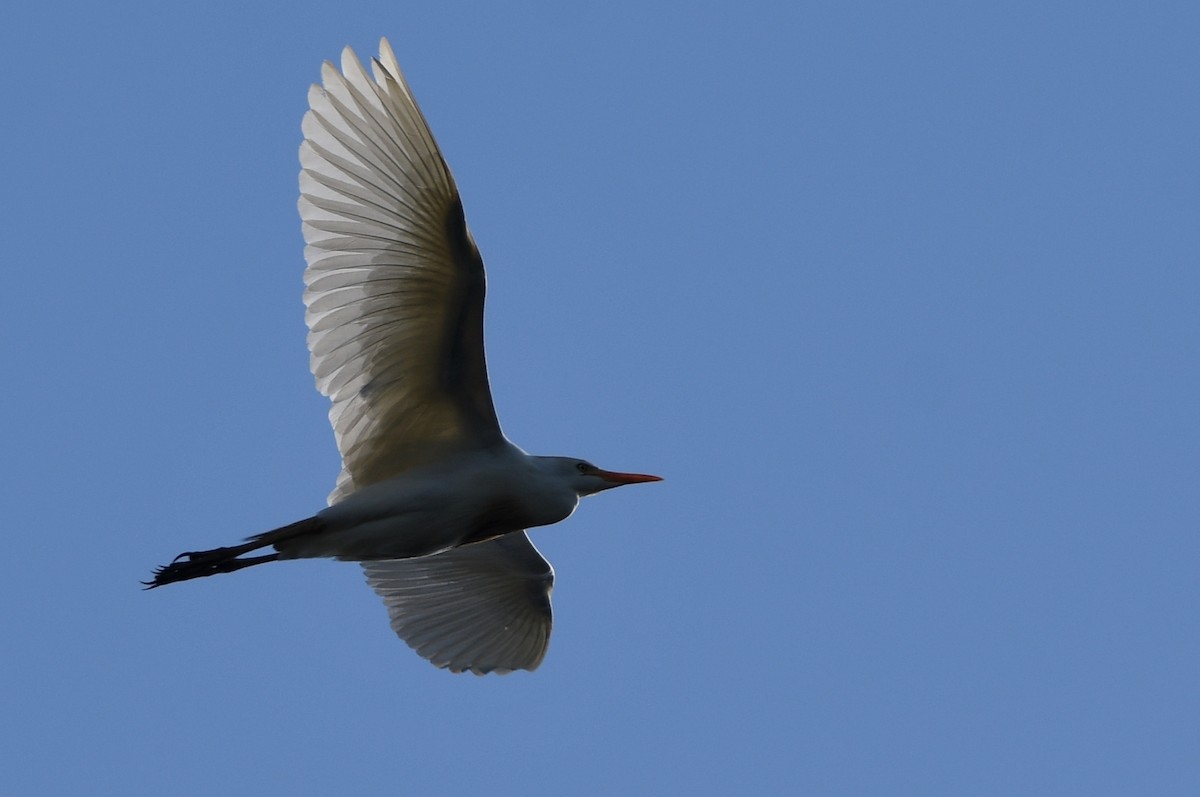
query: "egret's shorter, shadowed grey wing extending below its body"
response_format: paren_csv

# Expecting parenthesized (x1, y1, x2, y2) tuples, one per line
(362, 532, 554, 675)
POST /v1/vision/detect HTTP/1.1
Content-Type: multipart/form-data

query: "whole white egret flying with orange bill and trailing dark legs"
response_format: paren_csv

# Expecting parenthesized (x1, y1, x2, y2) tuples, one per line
(146, 40, 660, 675)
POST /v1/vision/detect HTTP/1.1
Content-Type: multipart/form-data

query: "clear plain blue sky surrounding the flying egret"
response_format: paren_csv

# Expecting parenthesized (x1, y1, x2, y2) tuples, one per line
(0, 0, 1200, 795)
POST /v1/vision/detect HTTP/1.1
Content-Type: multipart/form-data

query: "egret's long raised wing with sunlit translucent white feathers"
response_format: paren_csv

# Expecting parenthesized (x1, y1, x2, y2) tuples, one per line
(299, 40, 503, 501)
